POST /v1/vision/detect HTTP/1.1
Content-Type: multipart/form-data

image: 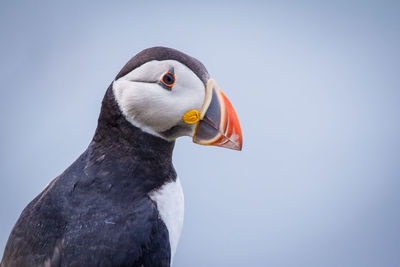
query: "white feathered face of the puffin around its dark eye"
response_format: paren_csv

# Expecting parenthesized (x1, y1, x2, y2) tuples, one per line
(113, 60, 205, 139)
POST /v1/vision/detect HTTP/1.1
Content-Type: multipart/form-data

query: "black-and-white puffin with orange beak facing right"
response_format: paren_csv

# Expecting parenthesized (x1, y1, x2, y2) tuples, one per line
(0, 47, 242, 267)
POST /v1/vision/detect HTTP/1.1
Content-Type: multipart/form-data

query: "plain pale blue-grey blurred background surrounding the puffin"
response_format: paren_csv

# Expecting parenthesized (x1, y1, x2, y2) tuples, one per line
(0, 1, 400, 267)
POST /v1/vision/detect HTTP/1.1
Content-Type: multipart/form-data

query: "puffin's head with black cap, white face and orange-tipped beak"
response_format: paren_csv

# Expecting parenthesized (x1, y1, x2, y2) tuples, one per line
(112, 47, 242, 150)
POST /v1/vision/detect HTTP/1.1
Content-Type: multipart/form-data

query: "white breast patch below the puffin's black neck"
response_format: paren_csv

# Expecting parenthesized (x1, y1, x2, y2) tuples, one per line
(149, 177, 184, 265)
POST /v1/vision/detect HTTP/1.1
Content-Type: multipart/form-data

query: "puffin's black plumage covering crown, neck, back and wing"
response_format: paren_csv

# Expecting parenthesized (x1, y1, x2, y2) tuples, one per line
(1, 47, 208, 267)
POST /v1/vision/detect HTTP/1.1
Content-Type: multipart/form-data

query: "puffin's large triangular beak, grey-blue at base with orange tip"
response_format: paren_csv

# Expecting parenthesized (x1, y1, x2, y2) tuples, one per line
(184, 79, 242, 150)
